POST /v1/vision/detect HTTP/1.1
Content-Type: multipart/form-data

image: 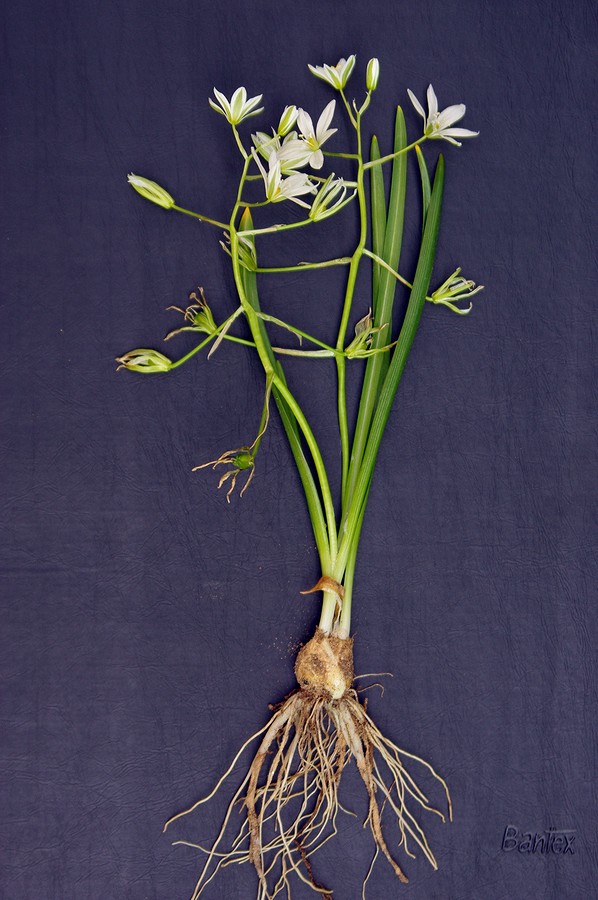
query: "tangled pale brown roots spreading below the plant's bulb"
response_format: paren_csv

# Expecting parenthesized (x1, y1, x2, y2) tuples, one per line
(165, 684, 452, 900)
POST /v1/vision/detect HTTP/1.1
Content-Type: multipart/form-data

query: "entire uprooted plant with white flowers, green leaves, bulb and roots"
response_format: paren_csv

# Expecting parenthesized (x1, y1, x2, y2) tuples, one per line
(118, 55, 481, 900)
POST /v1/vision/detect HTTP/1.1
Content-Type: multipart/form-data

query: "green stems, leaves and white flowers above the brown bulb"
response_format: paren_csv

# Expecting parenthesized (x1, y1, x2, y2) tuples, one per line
(120, 56, 480, 635)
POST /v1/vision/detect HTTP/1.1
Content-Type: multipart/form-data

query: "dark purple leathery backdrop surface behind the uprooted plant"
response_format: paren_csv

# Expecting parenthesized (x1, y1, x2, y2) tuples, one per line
(0, 0, 597, 900)
